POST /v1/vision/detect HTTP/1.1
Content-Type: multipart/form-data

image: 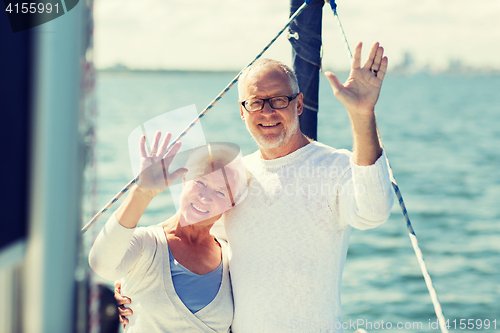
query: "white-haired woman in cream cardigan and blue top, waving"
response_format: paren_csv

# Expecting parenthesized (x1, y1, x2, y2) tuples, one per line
(89, 132, 246, 333)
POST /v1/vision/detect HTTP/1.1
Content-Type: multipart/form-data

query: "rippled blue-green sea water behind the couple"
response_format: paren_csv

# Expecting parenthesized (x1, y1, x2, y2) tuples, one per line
(95, 72, 500, 332)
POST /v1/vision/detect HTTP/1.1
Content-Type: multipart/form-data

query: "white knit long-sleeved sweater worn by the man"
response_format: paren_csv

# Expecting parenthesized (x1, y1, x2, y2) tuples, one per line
(222, 142, 394, 333)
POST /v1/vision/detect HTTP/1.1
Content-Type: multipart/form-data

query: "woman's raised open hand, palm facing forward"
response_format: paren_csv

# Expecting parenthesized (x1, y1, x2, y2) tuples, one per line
(137, 131, 187, 196)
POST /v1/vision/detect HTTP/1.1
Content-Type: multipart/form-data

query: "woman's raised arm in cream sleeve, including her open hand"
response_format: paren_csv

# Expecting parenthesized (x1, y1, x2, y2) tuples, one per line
(89, 132, 187, 280)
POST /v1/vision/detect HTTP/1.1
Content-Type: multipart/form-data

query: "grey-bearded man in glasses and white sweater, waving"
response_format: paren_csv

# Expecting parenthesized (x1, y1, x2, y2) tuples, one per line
(116, 43, 394, 333)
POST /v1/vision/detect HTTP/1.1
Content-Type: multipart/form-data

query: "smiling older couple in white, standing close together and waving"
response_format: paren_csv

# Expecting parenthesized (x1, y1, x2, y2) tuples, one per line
(89, 43, 393, 333)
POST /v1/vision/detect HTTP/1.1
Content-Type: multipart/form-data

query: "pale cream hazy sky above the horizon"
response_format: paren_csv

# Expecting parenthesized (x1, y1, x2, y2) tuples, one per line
(94, 0, 500, 70)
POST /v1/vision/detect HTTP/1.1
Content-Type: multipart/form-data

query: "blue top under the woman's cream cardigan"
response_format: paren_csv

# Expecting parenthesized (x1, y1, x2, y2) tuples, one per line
(168, 248, 222, 313)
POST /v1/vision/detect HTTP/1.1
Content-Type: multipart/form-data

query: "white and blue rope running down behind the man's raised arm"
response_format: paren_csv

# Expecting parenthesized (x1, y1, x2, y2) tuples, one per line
(327, 0, 448, 333)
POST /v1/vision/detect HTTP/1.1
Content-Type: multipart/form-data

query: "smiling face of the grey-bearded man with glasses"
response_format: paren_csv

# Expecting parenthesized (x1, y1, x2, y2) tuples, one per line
(240, 65, 303, 150)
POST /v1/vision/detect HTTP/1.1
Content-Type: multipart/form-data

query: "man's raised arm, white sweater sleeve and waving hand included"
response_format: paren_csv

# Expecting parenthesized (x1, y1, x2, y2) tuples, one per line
(325, 43, 394, 229)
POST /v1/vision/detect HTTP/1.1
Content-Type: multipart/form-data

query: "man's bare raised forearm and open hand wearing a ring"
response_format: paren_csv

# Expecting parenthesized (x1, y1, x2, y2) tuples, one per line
(325, 42, 388, 166)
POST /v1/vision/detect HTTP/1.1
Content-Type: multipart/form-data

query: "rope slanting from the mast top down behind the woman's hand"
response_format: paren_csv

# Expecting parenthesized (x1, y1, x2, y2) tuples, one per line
(81, 2, 307, 234)
